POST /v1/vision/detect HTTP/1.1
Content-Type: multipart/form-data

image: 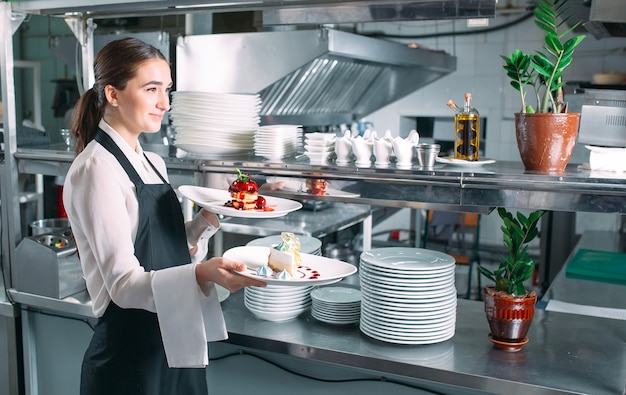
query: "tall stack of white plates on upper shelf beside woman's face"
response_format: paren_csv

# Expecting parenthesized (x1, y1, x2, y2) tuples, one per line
(170, 91, 261, 157)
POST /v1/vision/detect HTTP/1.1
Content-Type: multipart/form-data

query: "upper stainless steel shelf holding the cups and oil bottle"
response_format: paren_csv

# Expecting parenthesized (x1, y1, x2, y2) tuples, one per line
(15, 149, 626, 213)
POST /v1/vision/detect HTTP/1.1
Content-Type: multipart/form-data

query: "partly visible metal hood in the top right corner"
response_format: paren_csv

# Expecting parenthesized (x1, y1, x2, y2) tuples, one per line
(583, 0, 626, 39)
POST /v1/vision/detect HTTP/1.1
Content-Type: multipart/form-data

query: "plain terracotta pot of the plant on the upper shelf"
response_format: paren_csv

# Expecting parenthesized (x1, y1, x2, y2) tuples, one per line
(515, 113, 580, 173)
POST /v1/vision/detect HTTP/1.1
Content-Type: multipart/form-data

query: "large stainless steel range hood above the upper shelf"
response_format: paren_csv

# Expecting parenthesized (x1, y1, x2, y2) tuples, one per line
(176, 28, 456, 126)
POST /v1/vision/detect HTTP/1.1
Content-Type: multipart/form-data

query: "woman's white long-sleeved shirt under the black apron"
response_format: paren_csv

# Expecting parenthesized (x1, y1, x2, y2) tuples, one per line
(63, 121, 217, 317)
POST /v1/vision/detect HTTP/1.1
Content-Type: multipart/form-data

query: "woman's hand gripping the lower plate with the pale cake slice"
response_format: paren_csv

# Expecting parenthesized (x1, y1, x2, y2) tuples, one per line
(196, 257, 267, 292)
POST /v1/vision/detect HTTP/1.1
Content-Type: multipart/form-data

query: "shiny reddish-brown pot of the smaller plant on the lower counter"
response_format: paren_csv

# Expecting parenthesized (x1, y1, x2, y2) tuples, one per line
(482, 287, 537, 351)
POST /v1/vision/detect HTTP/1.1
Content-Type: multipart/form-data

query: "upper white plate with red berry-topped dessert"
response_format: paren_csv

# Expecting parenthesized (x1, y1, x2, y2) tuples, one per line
(178, 169, 302, 218)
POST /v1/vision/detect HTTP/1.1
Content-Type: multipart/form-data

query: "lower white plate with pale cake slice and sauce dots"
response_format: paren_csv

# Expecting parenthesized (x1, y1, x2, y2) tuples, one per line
(223, 232, 357, 286)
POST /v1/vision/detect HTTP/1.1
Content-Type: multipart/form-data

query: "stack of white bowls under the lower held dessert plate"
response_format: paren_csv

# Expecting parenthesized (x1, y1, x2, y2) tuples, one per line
(244, 284, 313, 321)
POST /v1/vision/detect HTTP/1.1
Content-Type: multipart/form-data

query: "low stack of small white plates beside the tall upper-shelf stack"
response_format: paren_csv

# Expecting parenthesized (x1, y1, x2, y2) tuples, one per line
(254, 125, 302, 160)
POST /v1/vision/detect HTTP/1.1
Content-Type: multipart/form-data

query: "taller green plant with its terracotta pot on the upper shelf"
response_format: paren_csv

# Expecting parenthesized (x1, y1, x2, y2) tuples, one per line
(500, 0, 585, 173)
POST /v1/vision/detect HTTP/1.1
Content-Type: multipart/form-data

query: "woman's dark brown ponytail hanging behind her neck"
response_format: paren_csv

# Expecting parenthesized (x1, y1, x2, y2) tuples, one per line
(72, 86, 104, 155)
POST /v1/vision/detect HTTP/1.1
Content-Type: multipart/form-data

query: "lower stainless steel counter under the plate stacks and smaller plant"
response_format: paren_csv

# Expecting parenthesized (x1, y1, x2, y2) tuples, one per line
(11, 280, 626, 395)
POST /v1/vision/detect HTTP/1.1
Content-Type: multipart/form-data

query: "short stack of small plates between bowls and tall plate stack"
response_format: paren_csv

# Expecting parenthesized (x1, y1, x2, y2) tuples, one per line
(311, 287, 361, 324)
